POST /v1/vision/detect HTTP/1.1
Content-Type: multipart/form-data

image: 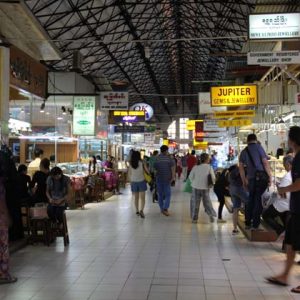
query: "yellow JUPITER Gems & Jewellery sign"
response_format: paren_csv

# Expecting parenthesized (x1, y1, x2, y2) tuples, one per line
(211, 85, 258, 107)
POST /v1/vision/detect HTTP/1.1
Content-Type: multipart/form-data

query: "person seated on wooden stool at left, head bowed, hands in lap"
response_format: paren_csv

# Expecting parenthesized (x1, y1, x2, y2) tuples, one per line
(46, 167, 70, 223)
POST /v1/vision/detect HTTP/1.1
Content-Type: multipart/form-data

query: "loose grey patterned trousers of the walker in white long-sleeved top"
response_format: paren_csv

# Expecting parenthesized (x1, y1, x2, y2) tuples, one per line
(190, 188, 217, 220)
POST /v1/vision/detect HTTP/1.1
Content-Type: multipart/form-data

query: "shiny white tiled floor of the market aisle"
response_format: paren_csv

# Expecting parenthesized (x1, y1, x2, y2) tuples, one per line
(0, 182, 300, 300)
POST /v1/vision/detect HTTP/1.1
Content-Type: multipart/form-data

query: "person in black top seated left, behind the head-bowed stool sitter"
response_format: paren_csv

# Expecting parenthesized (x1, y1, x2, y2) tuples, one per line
(30, 158, 50, 206)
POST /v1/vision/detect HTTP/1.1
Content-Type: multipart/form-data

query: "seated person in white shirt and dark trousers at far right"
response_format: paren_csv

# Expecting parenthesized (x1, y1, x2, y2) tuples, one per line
(262, 155, 293, 235)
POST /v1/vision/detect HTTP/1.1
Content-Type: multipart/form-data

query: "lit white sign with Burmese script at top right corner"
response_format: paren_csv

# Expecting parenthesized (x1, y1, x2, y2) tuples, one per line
(249, 13, 300, 40)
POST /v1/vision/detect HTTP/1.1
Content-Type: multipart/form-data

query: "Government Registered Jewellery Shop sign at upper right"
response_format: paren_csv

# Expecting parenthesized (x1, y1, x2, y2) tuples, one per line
(247, 51, 300, 66)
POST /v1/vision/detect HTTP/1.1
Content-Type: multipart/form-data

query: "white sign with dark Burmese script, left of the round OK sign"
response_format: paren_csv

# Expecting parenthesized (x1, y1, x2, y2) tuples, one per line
(100, 92, 128, 110)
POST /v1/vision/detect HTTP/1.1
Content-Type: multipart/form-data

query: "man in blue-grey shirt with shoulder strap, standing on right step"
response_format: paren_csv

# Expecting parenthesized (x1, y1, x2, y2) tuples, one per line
(239, 134, 272, 230)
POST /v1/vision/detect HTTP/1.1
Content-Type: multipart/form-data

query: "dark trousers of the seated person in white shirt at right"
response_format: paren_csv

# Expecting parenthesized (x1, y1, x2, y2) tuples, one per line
(263, 205, 289, 235)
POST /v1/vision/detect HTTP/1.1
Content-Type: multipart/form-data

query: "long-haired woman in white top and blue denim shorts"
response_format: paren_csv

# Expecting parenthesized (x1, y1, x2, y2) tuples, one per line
(128, 151, 149, 219)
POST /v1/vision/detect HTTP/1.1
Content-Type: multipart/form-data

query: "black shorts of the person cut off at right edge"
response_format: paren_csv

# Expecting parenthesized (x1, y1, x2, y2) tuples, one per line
(284, 214, 300, 251)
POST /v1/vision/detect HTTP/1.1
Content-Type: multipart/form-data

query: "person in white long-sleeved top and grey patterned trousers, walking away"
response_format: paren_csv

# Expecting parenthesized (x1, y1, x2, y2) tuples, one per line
(189, 153, 217, 223)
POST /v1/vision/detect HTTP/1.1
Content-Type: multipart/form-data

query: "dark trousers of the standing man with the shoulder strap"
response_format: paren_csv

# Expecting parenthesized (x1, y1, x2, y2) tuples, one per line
(245, 179, 268, 228)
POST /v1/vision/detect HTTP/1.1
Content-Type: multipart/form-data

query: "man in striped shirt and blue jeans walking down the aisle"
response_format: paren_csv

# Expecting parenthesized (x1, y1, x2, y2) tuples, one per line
(154, 145, 176, 216)
